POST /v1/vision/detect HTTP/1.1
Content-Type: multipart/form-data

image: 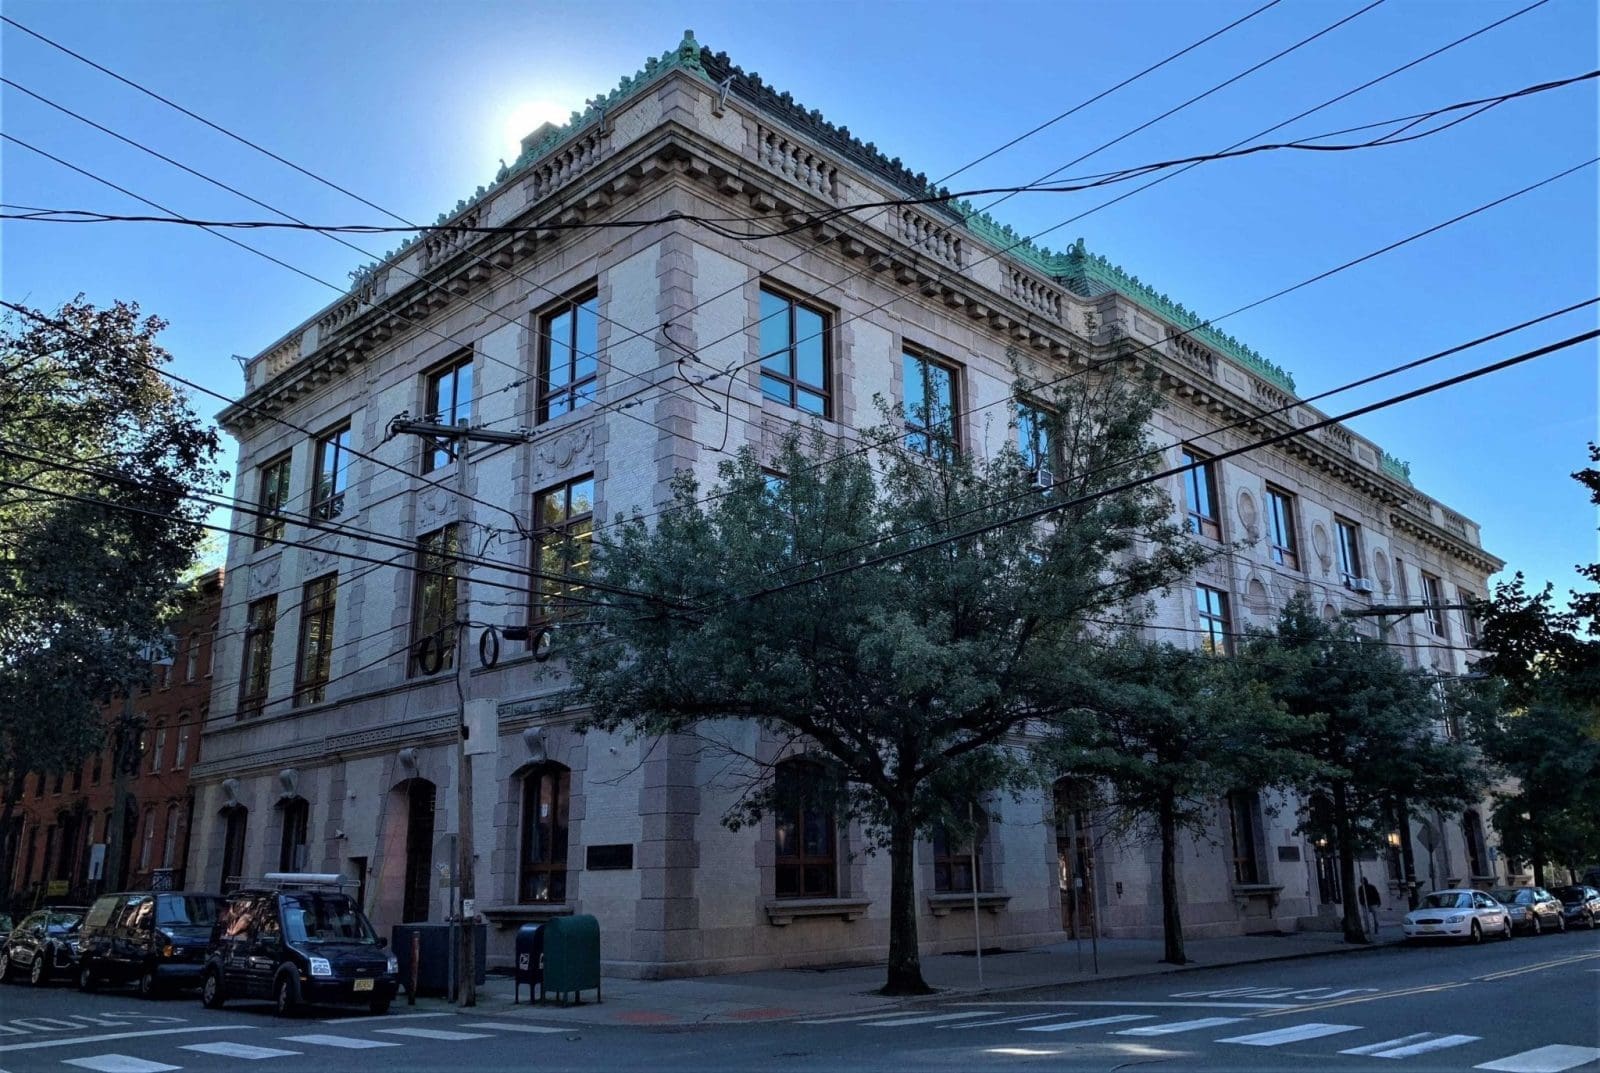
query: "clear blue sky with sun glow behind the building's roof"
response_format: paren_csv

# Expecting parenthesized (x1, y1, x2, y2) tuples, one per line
(0, 0, 1600, 592)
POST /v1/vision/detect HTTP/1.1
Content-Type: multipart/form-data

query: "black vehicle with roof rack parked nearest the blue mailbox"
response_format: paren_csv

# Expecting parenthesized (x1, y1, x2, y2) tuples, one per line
(200, 875, 400, 1017)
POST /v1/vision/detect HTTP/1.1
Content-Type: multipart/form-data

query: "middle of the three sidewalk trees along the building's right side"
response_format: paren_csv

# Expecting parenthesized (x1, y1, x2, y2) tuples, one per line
(1043, 638, 1315, 964)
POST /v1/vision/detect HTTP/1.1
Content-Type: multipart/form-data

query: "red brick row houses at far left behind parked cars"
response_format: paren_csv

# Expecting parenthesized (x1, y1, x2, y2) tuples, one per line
(0, 569, 222, 907)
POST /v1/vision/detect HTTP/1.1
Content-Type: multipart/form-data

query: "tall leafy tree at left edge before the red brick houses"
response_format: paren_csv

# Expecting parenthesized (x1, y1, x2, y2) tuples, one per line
(0, 299, 222, 895)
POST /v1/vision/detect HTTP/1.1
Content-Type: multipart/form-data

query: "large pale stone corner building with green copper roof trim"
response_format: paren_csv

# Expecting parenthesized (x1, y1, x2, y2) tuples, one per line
(190, 37, 1506, 977)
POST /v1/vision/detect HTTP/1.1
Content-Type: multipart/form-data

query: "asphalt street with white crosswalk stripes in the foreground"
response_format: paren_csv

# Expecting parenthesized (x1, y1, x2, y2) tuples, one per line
(0, 932, 1600, 1073)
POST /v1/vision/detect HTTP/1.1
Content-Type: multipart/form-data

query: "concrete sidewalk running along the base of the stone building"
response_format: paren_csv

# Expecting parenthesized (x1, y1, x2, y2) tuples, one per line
(409, 929, 1400, 1025)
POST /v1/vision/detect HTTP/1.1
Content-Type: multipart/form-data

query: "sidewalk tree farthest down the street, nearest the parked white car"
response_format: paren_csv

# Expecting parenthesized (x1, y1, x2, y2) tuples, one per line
(1242, 595, 1483, 943)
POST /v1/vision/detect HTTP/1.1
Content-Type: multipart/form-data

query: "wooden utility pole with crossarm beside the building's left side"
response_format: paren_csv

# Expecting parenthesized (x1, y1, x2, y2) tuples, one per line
(389, 419, 526, 1009)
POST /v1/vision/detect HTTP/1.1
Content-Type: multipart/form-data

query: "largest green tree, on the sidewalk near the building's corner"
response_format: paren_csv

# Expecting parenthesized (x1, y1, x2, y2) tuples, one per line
(571, 364, 1198, 995)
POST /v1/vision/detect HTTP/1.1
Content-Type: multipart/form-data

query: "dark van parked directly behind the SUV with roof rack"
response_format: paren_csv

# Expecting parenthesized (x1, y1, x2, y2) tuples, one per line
(78, 891, 222, 998)
